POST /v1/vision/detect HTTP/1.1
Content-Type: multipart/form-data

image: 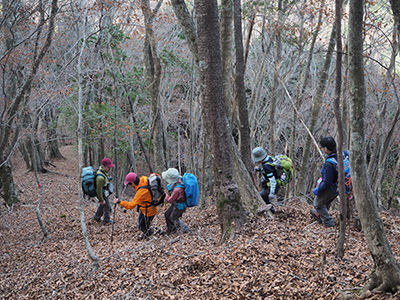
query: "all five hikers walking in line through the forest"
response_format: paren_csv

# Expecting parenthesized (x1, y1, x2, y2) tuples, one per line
(93, 136, 338, 239)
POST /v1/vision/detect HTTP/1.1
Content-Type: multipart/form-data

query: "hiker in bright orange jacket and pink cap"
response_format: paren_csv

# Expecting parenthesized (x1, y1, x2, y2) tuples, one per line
(114, 172, 158, 240)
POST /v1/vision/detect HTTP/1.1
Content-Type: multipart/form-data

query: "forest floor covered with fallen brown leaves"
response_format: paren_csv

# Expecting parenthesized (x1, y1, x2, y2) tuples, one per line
(0, 146, 400, 299)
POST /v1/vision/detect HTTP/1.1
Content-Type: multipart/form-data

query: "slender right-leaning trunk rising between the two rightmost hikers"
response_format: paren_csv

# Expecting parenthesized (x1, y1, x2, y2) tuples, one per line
(297, 26, 336, 195)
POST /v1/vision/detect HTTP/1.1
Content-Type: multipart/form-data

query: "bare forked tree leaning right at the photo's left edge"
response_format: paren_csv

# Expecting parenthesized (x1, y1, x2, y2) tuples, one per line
(0, 0, 58, 205)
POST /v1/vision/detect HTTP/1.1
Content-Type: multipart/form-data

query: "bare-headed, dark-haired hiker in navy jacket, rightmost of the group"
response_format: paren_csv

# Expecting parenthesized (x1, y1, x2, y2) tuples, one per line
(310, 136, 338, 227)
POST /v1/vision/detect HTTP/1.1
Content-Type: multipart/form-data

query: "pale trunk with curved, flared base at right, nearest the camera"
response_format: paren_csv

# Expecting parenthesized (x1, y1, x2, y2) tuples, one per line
(349, 0, 400, 295)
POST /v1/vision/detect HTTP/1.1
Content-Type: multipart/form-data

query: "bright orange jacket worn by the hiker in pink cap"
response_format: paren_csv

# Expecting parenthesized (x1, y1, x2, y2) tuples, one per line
(119, 176, 158, 217)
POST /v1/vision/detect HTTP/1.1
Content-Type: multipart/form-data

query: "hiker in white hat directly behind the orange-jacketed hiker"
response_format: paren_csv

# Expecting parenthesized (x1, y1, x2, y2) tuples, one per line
(161, 168, 187, 235)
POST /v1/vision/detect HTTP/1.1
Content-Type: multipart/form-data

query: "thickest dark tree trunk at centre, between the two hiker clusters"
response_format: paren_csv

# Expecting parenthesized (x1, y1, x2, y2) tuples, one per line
(195, 0, 247, 242)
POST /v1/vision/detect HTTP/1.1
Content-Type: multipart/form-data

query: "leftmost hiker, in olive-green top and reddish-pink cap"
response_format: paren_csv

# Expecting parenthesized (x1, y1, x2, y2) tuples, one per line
(93, 158, 114, 225)
